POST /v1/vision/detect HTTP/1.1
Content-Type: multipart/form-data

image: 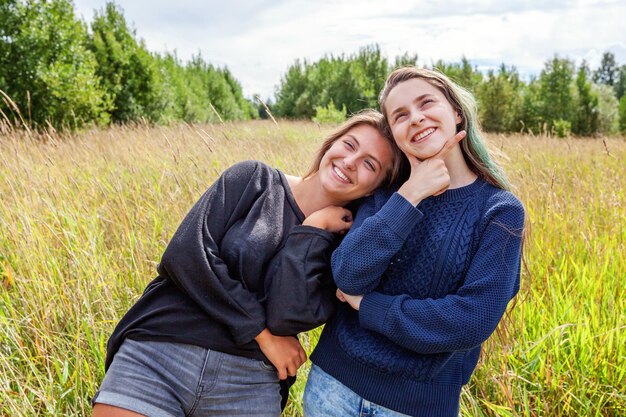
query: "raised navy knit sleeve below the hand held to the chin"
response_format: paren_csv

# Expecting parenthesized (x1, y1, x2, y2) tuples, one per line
(331, 193, 423, 295)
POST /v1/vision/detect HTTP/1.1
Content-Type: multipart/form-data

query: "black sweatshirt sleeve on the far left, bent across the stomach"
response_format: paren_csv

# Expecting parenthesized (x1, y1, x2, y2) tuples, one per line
(158, 162, 265, 344)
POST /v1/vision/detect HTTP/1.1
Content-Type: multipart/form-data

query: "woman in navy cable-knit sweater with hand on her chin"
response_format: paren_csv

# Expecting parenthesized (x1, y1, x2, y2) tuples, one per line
(304, 67, 524, 417)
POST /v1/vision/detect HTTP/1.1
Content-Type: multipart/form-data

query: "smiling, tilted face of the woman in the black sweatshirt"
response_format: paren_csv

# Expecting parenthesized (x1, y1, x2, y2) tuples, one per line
(318, 124, 393, 201)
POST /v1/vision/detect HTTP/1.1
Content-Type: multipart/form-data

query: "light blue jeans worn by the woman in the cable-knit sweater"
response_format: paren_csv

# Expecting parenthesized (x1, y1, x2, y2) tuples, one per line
(304, 365, 407, 417)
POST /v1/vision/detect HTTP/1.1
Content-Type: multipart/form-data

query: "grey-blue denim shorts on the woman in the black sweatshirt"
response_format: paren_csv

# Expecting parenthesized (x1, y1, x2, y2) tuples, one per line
(92, 339, 281, 417)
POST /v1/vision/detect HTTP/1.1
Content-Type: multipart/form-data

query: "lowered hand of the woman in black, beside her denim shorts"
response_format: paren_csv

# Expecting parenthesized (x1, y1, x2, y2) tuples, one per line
(254, 329, 306, 379)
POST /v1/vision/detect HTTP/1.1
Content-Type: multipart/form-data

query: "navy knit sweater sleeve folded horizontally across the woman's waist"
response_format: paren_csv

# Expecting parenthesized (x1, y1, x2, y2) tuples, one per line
(359, 197, 524, 354)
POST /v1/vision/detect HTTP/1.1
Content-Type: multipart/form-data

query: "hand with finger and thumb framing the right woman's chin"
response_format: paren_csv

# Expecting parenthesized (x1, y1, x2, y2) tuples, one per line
(398, 130, 466, 206)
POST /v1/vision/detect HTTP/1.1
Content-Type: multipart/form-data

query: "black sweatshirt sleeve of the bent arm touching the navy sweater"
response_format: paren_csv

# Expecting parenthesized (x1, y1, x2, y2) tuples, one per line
(265, 225, 337, 336)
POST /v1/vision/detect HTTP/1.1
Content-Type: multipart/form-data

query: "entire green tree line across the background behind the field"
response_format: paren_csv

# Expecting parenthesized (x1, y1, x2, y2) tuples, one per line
(0, 0, 626, 136)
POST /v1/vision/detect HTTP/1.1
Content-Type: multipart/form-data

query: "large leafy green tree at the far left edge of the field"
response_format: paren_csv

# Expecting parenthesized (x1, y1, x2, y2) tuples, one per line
(0, 0, 108, 128)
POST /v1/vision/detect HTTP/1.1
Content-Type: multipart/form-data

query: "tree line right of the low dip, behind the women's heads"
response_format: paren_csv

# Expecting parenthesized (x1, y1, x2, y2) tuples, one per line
(271, 45, 626, 136)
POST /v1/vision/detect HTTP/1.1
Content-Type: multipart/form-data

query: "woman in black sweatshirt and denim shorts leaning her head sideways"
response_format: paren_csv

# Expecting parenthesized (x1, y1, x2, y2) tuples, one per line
(93, 111, 400, 417)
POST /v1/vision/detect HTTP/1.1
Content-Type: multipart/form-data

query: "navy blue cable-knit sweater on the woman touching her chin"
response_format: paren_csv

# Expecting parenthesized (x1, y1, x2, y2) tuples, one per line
(311, 179, 524, 417)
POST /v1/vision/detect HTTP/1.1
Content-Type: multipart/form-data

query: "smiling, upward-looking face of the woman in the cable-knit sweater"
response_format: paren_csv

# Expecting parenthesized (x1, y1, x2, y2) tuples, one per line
(385, 78, 462, 160)
